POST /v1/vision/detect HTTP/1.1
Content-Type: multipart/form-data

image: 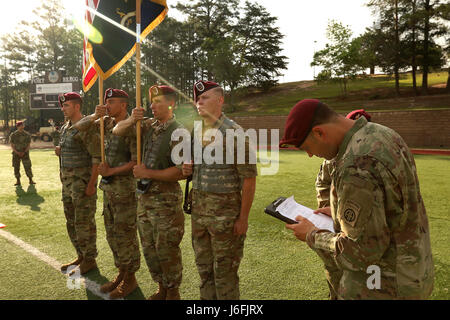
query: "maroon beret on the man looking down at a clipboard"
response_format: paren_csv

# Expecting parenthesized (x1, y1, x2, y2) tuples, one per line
(280, 99, 321, 148)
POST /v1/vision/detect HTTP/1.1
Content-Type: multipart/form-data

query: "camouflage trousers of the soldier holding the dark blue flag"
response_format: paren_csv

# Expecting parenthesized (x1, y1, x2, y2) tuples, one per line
(138, 188, 184, 288)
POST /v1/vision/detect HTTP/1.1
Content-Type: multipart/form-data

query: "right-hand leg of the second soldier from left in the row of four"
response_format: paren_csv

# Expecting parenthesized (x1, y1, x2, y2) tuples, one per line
(109, 192, 140, 273)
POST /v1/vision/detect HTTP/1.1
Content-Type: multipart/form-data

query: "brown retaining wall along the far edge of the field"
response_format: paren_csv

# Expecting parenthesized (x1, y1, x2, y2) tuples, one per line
(230, 110, 450, 149)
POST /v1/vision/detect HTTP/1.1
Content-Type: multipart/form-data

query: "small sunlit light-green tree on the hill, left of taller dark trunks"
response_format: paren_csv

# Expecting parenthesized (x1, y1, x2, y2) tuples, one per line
(311, 20, 362, 95)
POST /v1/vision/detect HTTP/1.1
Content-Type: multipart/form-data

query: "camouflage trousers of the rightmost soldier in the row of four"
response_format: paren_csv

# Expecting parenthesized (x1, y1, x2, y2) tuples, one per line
(191, 189, 245, 300)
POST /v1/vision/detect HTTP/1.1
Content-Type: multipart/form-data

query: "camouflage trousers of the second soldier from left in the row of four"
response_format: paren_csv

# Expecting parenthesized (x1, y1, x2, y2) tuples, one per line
(103, 191, 141, 272)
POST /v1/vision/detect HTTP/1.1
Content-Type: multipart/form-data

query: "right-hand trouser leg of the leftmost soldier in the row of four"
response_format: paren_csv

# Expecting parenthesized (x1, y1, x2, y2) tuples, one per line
(71, 175, 97, 262)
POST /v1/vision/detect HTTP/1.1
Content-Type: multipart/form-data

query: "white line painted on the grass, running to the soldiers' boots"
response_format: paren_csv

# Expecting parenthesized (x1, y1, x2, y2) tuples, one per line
(0, 229, 119, 300)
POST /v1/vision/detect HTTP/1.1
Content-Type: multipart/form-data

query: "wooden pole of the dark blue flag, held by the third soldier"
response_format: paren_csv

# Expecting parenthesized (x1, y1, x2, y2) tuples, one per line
(136, 0, 141, 165)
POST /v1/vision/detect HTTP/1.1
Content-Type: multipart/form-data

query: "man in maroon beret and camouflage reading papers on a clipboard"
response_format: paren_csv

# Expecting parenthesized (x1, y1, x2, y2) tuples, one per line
(280, 99, 434, 299)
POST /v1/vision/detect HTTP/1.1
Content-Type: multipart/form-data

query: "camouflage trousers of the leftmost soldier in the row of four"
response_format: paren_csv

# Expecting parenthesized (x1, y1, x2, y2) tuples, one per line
(61, 168, 97, 259)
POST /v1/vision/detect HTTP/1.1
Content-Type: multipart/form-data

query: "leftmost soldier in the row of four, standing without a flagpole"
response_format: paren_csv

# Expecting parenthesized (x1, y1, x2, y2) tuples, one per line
(55, 92, 101, 274)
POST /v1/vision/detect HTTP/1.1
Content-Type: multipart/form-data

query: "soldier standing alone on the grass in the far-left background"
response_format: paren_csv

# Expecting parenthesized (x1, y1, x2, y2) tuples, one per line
(9, 121, 35, 186)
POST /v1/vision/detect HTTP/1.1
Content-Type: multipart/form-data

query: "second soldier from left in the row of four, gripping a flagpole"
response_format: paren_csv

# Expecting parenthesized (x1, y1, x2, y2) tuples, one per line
(74, 88, 140, 299)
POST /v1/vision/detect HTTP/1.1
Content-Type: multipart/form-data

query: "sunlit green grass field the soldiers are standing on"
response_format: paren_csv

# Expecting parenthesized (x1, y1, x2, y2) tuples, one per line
(0, 150, 450, 300)
